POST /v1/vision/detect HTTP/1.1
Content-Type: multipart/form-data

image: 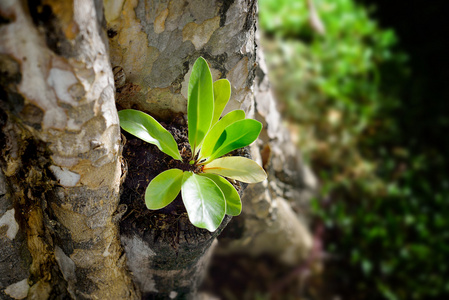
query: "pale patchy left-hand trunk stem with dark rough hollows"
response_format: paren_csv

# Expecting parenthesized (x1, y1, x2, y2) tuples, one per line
(0, 0, 137, 299)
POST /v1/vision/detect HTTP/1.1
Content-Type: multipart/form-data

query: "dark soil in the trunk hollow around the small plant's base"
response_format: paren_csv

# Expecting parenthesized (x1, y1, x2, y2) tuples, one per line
(120, 115, 249, 248)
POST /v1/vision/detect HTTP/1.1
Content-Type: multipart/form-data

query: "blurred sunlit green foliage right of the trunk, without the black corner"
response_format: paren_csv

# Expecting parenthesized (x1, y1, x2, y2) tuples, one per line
(259, 0, 449, 299)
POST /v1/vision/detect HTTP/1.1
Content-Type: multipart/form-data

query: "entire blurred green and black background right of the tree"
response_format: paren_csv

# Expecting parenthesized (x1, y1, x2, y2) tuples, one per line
(204, 0, 449, 300)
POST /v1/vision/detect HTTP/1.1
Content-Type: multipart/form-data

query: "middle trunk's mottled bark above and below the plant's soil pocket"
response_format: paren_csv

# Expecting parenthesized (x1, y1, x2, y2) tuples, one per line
(105, 0, 256, 299)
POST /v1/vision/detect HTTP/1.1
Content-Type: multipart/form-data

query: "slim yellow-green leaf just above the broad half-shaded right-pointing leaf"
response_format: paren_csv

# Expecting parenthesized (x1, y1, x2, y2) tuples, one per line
(199, 109, 245, 160)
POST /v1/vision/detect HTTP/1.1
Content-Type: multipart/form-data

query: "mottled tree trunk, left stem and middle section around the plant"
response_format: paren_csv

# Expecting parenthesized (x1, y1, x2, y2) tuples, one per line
(0, 0, 256, 299)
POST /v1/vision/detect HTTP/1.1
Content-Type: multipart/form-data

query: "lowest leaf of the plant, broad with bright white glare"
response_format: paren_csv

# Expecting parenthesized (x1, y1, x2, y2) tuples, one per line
(181, 172, 226, 232)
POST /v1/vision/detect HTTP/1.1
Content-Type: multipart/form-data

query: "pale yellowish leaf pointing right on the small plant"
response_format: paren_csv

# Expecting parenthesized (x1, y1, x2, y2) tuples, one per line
(203, 156, 267, 183)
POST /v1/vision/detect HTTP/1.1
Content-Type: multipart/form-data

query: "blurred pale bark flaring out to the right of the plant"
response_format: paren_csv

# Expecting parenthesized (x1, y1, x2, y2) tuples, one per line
(213, 30, 317, 266)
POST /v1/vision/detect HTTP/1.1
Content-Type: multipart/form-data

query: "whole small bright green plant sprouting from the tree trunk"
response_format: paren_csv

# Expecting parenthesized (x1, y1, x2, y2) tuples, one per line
(118, 57, 267, 231)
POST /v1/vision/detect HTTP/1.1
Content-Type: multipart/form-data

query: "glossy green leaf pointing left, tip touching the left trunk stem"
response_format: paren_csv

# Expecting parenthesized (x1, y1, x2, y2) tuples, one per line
(118, 109, 182, 160)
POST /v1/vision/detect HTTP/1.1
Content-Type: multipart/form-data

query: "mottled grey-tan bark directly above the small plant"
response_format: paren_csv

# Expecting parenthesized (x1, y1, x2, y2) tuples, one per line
(105, 0, 256, 119)
